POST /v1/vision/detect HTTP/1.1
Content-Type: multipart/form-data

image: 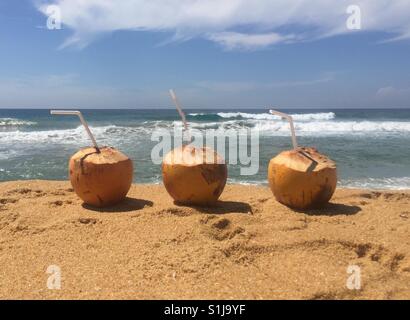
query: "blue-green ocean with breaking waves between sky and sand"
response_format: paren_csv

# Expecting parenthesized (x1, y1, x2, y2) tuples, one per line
(0, 109, 410, 190)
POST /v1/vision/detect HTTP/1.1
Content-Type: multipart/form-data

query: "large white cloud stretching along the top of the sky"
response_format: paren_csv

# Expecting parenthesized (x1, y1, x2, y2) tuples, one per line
(34, 0, 410, 50)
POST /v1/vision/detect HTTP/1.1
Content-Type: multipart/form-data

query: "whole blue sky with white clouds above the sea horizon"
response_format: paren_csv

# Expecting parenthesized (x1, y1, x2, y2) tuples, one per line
(0, 0, 410, 109)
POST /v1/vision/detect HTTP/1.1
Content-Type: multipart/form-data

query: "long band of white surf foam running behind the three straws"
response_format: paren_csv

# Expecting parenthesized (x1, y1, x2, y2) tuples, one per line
(0, 119, 410, 146)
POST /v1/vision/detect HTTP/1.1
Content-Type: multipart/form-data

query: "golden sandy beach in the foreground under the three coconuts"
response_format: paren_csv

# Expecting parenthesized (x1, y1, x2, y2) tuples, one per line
(0, 181, 410, 299)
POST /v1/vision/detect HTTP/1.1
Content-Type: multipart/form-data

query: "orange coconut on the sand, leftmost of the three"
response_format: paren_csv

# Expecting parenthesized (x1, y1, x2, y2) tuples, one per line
(69, 147, 133, 207)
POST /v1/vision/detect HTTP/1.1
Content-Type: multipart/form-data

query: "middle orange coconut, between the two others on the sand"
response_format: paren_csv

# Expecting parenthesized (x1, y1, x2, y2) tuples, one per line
(162, 145, 228, 205)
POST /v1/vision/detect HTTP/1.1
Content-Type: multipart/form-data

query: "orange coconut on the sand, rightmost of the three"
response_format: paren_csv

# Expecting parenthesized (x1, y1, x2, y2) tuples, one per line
(268, 148, 337, 209)
